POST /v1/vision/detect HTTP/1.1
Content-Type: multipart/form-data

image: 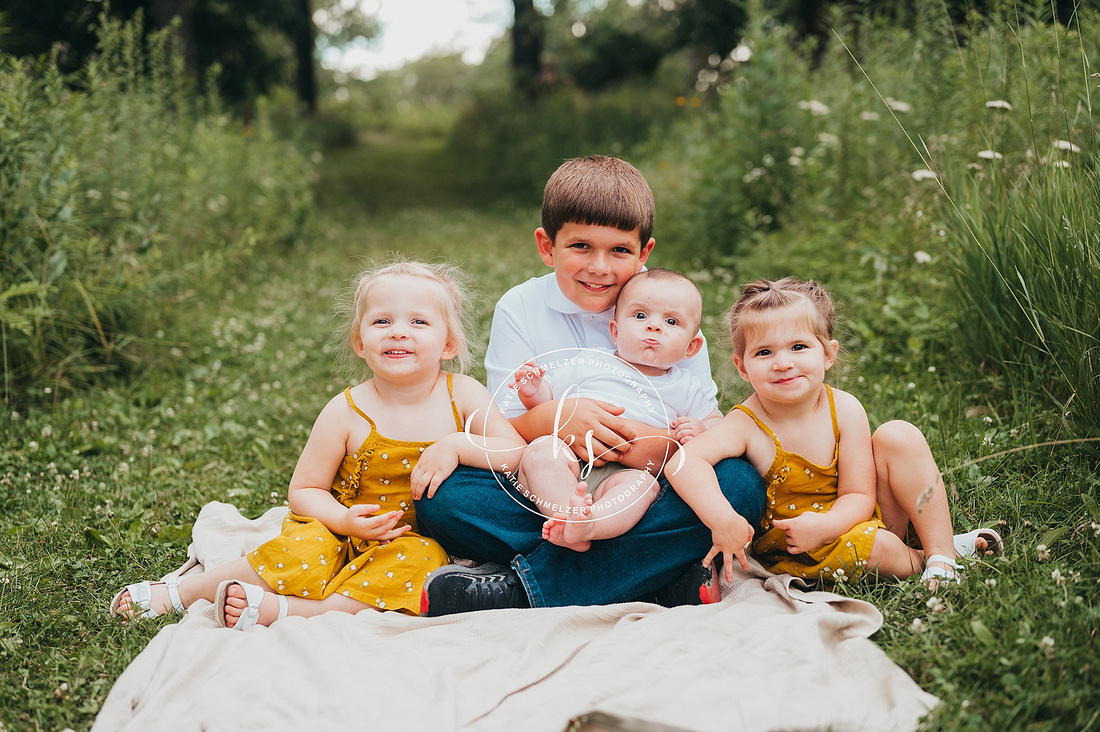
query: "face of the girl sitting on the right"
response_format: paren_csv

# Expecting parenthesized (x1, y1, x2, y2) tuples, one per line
(734, 303, 840, 404)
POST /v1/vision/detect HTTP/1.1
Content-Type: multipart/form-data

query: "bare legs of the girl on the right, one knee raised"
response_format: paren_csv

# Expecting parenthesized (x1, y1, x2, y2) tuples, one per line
(871, 420, 959, 577)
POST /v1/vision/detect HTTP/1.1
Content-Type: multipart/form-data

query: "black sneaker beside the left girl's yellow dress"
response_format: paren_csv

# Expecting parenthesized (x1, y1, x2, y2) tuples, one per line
(420, 564, 531, 618)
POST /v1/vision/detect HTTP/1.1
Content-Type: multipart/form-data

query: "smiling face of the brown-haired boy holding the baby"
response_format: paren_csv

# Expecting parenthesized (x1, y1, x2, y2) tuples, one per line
(535, 223, 653, 313)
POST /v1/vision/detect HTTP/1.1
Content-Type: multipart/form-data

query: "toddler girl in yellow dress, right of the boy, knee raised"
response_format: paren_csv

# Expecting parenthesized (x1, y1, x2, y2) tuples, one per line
(666, 278, 1001, 583)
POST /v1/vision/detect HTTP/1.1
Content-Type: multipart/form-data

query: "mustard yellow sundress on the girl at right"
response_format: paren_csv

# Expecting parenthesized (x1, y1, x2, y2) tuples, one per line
(734, 385, 886, 581)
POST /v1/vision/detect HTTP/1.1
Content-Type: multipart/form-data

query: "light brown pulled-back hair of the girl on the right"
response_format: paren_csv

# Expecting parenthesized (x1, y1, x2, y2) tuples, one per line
(726, 277, 836, 357)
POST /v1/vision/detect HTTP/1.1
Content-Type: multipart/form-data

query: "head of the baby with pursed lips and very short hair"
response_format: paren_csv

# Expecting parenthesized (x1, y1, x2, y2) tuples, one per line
(612, 281, 703, 376)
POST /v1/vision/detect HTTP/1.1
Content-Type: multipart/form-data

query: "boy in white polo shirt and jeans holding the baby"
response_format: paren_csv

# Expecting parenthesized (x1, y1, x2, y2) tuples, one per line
(416, 155, 765, 615)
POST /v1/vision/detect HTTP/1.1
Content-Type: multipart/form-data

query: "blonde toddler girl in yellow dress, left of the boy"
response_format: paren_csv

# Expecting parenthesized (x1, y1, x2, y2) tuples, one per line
(111, 262, 525, 630)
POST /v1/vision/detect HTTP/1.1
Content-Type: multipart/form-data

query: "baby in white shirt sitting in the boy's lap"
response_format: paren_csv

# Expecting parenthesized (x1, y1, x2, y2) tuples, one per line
(512, 269, 722, 551)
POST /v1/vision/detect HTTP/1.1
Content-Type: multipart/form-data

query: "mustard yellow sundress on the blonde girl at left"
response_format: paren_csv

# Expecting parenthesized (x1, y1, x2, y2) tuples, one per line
(248, 374, 453, 615)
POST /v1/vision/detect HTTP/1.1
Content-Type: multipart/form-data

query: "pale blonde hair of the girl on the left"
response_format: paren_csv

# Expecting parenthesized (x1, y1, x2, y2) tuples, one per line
(338, 260, 470, 378)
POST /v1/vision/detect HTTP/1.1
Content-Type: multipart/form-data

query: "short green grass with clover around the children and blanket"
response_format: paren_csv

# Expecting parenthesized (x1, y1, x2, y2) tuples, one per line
(0, 125, 1100, 730)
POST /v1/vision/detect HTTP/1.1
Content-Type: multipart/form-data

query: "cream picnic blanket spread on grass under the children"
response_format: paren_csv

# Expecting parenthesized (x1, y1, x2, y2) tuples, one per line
(92, 503, 937, 732)
